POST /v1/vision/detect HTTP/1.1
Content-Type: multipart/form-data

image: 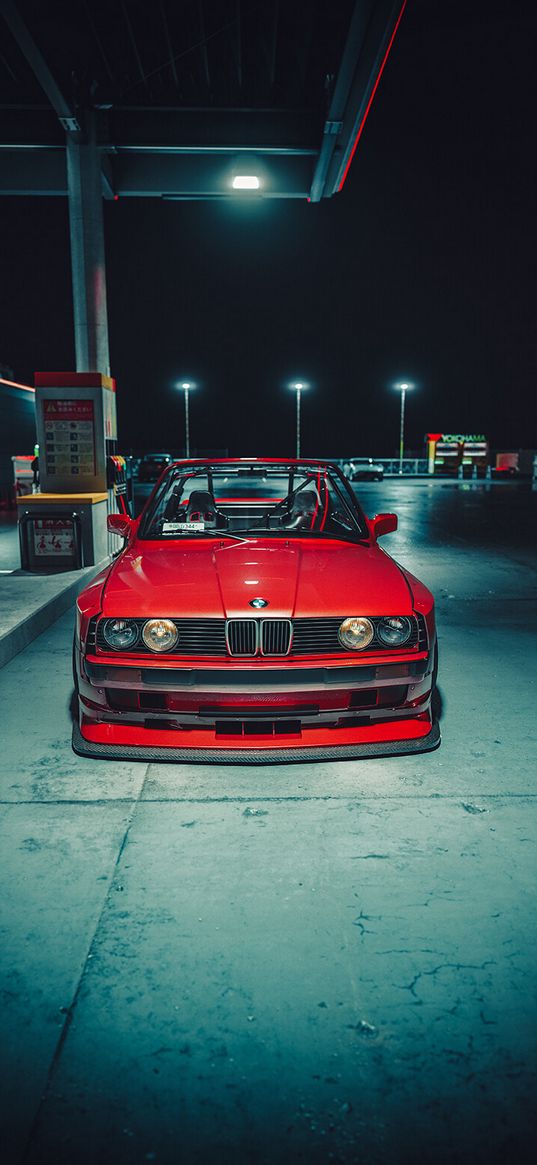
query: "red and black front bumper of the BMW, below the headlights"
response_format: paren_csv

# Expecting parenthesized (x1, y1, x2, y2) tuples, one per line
(73, 652, 440, 764)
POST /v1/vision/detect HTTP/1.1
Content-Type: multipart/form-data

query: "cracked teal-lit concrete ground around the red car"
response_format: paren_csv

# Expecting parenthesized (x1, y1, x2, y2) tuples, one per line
(0, 482, 537, 1165)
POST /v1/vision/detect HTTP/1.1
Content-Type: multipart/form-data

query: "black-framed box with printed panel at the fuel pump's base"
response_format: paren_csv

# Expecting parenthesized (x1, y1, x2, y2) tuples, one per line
(19, 510, 84, 571)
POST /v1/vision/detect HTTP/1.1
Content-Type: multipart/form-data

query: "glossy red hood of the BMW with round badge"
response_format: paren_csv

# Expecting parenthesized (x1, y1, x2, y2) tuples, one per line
(103, 539, 412, 619)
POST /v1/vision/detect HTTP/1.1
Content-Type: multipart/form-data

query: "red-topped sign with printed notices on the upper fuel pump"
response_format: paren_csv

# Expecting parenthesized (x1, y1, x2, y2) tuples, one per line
(43, 401, 96, 478)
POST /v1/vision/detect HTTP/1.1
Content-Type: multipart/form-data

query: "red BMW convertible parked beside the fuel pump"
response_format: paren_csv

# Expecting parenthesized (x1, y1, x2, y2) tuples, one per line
(73, 458, 440, 764)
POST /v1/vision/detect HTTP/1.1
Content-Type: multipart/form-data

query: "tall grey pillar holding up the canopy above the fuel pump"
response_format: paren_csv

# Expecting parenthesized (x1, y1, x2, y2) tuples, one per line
(66, 115, 109, 376)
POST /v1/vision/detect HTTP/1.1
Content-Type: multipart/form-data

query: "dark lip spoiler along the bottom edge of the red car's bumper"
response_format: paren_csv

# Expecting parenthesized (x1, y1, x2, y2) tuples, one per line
(72, 720, 440, 764)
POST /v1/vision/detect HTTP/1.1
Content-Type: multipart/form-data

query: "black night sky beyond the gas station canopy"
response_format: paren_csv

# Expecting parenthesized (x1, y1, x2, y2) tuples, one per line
(0, 0, 537, 457)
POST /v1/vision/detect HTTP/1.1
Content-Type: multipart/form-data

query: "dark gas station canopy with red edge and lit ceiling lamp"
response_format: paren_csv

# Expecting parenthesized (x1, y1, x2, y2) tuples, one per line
(0, 0, 405, 202)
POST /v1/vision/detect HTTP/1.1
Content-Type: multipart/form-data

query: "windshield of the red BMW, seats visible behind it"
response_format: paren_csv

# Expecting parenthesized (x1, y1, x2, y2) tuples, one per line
(139, 461, 368, 542)
